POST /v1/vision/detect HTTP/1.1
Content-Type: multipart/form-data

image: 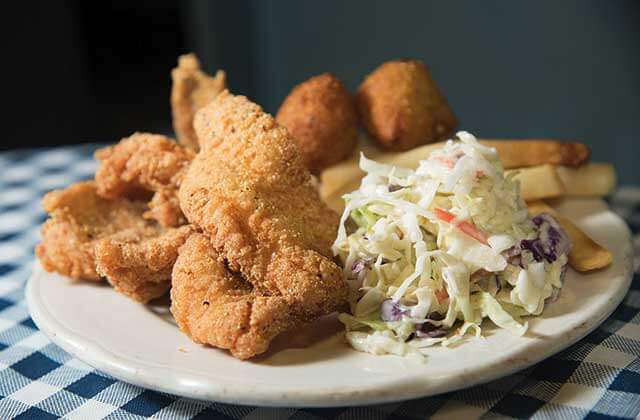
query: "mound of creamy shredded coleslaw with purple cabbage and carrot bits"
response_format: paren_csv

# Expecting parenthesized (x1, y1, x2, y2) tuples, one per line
(333, 132, 571, 358)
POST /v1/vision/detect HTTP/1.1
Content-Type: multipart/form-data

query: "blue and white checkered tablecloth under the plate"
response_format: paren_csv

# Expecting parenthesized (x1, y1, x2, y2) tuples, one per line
(0, 146, 640, 419)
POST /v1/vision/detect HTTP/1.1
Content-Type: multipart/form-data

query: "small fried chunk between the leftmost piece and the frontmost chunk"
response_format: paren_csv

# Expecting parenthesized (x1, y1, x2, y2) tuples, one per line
(94, 225, 192, 303)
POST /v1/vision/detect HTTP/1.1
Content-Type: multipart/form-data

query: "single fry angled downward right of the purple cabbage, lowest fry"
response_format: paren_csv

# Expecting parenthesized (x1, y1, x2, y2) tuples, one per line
(527, 201, 613, 272)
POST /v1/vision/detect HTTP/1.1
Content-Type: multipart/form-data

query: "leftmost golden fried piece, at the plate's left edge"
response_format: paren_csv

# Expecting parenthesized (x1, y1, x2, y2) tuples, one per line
(36, 181, 149, 281)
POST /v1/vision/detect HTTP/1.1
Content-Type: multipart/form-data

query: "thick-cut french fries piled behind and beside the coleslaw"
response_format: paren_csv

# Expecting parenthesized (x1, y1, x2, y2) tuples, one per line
(320, 140, 616, 271)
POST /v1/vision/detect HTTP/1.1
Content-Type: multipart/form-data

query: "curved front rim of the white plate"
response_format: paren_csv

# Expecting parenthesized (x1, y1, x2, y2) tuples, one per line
(25, 203, 633, 408)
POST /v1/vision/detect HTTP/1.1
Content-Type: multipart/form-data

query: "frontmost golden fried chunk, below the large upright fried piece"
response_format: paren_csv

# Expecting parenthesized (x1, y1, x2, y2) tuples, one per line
(171, 234, 304, 359)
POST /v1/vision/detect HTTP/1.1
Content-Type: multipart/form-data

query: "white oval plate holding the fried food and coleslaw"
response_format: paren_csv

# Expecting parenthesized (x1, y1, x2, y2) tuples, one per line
(27, 200, 631, 406)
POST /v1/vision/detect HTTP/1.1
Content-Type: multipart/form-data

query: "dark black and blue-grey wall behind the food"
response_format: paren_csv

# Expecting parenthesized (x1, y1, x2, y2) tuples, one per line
(0, 0, 640, 184)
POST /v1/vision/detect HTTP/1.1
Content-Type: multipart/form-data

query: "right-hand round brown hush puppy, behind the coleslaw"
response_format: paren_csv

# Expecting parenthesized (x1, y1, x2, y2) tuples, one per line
(357, 60, 457, 151)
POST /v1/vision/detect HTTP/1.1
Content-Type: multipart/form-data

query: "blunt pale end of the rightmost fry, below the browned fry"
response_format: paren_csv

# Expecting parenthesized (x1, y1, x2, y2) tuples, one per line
(556, 163, 616, 197)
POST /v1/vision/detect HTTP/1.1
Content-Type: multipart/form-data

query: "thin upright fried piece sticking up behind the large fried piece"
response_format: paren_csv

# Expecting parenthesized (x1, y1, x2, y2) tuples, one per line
(171, 54, 227, 151)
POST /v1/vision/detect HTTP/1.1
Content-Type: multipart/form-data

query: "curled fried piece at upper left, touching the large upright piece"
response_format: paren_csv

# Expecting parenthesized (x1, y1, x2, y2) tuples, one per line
(95, 133, 195, 227)
